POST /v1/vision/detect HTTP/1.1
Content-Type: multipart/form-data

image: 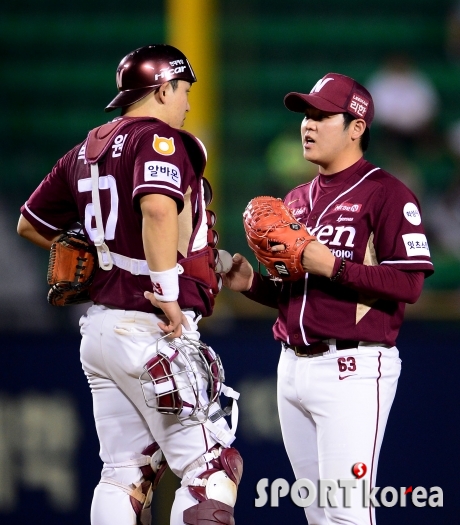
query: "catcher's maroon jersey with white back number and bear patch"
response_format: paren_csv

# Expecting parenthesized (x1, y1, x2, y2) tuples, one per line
(21, 118, 217, 315)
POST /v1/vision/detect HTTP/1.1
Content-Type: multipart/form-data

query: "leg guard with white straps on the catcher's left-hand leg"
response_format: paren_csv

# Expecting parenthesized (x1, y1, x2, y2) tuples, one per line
(101, 443, 167, 525)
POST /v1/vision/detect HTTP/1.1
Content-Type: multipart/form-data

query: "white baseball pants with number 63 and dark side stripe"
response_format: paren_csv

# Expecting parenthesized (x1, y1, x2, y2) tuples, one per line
(278, 340, 401, 525)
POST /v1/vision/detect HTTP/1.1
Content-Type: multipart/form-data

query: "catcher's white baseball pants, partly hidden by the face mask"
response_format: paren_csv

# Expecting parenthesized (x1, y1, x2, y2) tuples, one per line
(80, 305, 229, 525)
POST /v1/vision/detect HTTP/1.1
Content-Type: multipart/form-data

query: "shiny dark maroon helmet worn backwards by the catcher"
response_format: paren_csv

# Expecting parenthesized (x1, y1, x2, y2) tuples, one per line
(105, 44, 196, 111)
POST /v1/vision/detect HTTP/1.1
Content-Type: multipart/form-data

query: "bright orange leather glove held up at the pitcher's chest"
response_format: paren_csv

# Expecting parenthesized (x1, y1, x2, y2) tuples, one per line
(243, 197, 316, 281)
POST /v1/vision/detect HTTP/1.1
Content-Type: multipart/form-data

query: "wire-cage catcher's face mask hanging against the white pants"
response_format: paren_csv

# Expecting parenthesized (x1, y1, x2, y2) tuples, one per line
(139, 336, 225, 426)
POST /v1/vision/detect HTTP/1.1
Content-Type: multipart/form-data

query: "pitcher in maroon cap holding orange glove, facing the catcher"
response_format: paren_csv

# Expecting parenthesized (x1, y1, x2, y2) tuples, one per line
(224, 73, 433, 525)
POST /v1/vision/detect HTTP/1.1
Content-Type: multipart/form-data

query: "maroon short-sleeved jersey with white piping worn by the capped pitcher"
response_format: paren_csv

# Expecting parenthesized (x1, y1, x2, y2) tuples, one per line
(247, 159, 433, 345)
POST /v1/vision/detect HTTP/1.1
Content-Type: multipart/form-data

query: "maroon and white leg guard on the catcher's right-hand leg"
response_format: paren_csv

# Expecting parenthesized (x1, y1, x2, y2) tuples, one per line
(184, 447, 243, 525)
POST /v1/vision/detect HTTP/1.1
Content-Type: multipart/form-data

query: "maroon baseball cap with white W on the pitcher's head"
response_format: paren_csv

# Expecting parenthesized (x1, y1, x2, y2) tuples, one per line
(284, 73, 374, 128)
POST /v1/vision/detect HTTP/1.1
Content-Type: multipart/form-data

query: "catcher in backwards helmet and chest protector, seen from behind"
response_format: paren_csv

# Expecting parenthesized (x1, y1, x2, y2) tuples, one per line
(18, 44, 242, 525)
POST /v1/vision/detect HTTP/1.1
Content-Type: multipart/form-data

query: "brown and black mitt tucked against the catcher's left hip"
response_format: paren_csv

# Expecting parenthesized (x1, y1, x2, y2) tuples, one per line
(48, 232, 97, 306)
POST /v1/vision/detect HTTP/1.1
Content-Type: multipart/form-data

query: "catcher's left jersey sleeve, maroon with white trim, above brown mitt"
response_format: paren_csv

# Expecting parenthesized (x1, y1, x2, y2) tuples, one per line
(21, 154, 79, 234)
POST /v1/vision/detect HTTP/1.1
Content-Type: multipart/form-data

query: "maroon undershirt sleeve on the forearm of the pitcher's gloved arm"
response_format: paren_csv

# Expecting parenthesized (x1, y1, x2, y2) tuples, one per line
(334, 259, 425, 304)
